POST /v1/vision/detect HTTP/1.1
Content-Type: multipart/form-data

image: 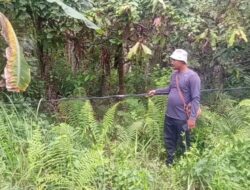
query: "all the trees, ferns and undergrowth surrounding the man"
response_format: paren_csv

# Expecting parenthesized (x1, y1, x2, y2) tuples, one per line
(0, 0, 250, 190)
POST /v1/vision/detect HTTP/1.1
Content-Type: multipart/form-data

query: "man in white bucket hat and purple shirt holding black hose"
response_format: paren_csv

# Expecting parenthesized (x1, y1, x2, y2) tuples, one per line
(148, 49, 200, 165)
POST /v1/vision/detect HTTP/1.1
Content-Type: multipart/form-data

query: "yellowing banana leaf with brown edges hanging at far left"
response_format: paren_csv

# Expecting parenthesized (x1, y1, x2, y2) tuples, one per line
(0, 12, 31, 92)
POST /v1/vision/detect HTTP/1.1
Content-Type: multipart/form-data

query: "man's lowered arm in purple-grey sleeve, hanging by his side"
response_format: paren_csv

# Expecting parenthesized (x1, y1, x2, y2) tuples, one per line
(189, 74, 201, 122)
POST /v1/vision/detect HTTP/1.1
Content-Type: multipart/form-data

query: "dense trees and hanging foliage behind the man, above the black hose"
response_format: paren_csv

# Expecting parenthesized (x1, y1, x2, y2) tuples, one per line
(0, 0, 250, 99)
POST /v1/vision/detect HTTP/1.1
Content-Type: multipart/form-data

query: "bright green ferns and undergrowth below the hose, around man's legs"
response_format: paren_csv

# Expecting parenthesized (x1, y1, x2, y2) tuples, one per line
(0, 97, 250, 190)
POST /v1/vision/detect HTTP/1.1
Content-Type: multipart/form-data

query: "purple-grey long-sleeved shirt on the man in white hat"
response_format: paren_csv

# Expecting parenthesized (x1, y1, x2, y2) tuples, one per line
(156, 69, 201, 120)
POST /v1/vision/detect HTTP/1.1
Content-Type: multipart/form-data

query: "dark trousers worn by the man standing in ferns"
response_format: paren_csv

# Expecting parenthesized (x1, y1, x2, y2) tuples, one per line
(164, 116, 190, 165)
